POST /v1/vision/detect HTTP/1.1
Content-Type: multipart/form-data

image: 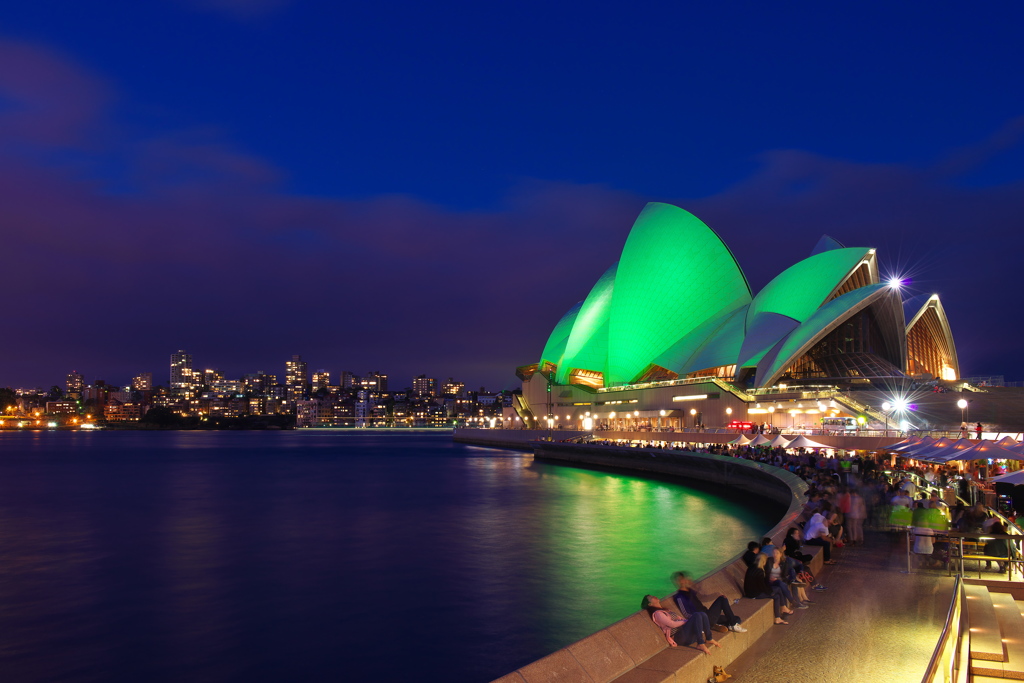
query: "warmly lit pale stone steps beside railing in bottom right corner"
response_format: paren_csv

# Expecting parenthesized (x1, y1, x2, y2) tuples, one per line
(966, 585, 1024, 683)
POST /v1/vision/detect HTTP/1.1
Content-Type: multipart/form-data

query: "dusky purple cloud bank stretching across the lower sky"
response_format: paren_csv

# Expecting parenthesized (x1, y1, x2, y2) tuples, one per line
(0, 41, 1024, 388)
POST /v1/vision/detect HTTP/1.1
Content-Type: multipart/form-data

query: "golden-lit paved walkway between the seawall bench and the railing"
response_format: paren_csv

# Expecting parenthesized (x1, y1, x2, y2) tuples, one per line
(728, 531, 953, 683)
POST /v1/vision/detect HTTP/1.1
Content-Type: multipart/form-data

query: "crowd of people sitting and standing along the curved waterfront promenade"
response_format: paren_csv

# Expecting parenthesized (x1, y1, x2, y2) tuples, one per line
(592, 440, 1016, 653)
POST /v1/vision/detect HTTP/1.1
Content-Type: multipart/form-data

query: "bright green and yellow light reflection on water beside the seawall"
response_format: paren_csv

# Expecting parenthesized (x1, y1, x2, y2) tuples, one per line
(520, 463, 774, 649)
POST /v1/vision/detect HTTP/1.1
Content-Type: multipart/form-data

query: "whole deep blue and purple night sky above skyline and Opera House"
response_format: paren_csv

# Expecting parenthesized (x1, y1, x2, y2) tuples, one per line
(0, 0, 1024, 389)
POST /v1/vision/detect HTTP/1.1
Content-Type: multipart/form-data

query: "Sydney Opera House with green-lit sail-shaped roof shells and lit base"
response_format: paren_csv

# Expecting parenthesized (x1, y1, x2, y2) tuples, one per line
(517, 203, 958, 428)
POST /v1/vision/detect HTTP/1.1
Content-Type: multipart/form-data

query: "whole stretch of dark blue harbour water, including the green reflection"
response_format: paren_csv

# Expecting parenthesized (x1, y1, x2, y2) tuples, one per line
(0, 431, 773, 682)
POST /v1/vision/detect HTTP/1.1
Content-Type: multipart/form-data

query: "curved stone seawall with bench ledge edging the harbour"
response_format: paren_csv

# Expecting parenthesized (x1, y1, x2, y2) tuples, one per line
(456, 430, 806, 683)
